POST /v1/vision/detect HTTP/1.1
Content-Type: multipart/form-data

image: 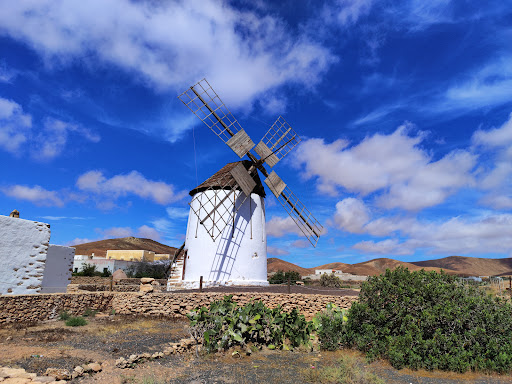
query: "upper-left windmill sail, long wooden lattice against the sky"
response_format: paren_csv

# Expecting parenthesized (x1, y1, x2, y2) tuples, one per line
(178, 79, 254, 158)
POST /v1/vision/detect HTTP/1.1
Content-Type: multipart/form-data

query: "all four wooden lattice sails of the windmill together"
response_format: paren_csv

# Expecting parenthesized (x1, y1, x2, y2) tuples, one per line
(178, 79, 323, 246)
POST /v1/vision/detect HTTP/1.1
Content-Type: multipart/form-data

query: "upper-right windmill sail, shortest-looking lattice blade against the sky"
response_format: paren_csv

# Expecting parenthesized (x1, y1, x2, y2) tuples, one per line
(254, 116, 301, 167)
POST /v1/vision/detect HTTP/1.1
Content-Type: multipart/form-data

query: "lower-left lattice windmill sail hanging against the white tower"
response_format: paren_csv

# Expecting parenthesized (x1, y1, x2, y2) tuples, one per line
(189, 173, 251, 241)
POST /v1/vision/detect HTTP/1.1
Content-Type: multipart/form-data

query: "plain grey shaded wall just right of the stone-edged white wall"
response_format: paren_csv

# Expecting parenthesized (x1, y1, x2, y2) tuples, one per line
(41, 244, 75, 293)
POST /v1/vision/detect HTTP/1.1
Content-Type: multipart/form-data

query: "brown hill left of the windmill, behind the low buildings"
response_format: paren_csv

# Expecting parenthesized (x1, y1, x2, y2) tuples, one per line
(72, 237, 176, 257)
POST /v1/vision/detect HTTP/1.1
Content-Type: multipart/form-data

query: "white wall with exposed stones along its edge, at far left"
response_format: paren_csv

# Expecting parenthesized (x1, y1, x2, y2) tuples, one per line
(0, 216, 50, 294)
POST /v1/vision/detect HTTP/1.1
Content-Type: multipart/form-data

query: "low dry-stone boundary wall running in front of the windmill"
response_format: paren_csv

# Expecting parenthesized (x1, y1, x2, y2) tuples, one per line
(0, 292, 357, 326)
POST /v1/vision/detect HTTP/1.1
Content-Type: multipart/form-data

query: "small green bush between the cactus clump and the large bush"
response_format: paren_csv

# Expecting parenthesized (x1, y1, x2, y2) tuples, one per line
(313, 303, 348, 351)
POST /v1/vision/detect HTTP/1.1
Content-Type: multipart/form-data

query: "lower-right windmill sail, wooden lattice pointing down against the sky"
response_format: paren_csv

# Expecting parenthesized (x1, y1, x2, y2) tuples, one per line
(265, 171, 323, 247)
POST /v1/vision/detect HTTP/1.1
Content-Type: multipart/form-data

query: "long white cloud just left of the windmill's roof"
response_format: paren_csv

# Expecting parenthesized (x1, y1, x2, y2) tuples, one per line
(76, 171, 185, 204)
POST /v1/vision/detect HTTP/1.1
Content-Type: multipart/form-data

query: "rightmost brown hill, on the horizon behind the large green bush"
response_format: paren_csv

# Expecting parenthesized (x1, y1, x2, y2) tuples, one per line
(411, 256, 512, 276)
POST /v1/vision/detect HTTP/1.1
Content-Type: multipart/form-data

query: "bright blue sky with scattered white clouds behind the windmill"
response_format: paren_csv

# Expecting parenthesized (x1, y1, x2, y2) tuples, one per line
(0, 0, 512, 267)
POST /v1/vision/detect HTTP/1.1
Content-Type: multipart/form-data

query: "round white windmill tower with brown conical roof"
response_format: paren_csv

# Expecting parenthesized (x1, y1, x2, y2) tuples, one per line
(169, 162, 268, 289)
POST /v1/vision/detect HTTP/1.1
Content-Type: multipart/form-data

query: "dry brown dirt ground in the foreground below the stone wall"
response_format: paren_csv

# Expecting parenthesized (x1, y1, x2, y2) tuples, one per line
(0, 315, 512, 384)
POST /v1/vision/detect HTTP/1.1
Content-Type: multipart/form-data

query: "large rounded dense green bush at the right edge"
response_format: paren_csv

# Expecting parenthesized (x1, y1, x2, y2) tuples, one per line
(340, 267, 512, 373)
